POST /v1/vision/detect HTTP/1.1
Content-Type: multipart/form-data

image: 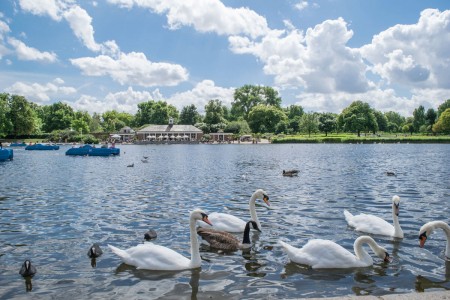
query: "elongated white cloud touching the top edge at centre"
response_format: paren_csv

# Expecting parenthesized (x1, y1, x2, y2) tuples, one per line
(108, 0, 269, 38)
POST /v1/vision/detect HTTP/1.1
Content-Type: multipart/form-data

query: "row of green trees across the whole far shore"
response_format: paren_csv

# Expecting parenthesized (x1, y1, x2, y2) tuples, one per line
(0, 85, 450, 141)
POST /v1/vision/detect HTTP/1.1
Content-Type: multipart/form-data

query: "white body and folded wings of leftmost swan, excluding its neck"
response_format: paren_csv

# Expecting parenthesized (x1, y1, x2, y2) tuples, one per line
(108, 243, 191, 271)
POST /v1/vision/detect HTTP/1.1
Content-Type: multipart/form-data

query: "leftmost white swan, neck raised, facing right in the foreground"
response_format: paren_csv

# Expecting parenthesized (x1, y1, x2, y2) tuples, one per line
(108, 209, 211, 271)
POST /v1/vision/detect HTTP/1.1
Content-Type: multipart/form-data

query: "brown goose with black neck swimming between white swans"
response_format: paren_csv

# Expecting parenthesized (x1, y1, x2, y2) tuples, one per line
(197, 221, 261, 251)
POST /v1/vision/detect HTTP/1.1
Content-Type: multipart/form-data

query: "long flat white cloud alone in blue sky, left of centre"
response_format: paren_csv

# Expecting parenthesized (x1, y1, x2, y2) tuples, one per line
(70, 52, 188, 87)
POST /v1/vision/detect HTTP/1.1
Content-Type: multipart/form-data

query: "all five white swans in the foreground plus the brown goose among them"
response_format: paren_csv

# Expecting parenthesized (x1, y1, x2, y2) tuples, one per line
(108, 189, 450, 271)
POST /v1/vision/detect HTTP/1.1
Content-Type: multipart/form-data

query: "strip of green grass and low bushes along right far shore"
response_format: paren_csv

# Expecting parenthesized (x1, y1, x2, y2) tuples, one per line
(271, 134, 450, 144)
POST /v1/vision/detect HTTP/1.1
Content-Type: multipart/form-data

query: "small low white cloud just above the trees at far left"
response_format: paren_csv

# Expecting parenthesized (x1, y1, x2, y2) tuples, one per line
(5, 78, 77, 103)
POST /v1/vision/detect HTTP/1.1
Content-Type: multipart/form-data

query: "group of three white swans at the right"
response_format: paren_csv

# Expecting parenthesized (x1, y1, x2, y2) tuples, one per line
(279, 195, 450, 269)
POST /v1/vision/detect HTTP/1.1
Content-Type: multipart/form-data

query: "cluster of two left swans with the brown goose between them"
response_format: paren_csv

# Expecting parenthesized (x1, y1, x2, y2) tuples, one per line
(108, 189, 270, 271)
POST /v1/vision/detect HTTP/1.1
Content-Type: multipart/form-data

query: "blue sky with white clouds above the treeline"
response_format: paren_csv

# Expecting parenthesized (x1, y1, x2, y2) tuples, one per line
(0, 0, 450, 116)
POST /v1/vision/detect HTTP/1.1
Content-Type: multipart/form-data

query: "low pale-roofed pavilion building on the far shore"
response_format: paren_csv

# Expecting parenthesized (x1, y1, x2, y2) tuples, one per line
(136, 119, 203, 142)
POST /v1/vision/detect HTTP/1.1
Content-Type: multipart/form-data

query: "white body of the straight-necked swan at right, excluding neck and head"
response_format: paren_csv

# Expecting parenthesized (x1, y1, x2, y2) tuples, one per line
(344, 211, 394, 236)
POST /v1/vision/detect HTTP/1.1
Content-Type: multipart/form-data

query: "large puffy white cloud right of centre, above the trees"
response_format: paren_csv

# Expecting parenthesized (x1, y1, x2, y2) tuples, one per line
(229, 18, 373, 93)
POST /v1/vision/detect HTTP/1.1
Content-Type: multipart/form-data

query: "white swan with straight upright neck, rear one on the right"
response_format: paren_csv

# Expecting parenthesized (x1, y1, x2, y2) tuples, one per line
(344, 195, 403, 239)
